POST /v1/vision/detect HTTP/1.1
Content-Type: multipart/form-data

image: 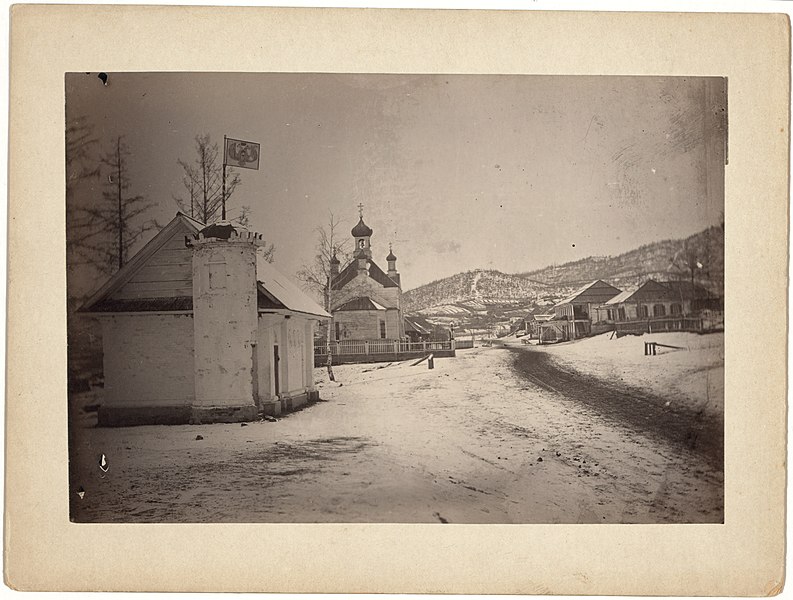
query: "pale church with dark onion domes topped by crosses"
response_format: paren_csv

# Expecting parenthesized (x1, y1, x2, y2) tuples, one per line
(330, 210, 405, 342)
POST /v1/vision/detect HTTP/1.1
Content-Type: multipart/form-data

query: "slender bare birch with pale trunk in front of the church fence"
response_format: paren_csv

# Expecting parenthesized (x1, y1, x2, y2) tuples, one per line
(297, 212, 350, 381)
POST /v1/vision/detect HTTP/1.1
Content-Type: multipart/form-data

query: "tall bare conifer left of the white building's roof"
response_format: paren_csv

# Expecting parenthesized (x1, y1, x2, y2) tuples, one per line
(67, 136, 161, 274)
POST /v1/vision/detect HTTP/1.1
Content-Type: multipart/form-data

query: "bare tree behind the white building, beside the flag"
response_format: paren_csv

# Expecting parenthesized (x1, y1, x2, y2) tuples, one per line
(174, 134, 241, 224)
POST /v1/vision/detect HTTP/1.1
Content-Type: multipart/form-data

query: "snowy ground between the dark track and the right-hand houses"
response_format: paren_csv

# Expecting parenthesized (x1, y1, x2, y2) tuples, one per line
(507, 332, 724, 415)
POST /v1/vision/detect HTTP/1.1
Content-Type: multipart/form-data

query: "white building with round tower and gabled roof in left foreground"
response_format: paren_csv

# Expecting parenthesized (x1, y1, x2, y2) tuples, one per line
(81, 213, 330, 426)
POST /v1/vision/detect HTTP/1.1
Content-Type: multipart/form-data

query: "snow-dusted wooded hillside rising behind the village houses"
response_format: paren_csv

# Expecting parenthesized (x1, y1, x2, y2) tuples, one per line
(402, 227, 724, 316)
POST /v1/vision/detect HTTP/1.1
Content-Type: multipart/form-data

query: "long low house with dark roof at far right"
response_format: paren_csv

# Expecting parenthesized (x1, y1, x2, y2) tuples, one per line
(601, 279, 722, 333)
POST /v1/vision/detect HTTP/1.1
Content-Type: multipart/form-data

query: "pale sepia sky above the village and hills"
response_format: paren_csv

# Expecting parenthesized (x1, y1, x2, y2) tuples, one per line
(66, 73, 726, 290)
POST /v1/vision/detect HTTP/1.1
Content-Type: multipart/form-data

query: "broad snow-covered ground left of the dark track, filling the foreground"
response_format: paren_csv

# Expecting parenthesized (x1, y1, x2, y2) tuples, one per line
(72, 347, 723, 523)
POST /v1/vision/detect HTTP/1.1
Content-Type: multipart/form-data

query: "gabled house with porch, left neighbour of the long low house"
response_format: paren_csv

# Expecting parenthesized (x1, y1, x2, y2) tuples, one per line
(538, 279, 620, 343)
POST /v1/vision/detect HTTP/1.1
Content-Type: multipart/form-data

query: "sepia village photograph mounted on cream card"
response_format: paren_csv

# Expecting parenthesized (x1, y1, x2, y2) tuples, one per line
(64, 72, 728, 525)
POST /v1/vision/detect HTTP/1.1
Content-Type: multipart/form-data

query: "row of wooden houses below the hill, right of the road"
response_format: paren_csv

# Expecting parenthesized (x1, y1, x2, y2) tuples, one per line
(522, 279, 723, 343)
